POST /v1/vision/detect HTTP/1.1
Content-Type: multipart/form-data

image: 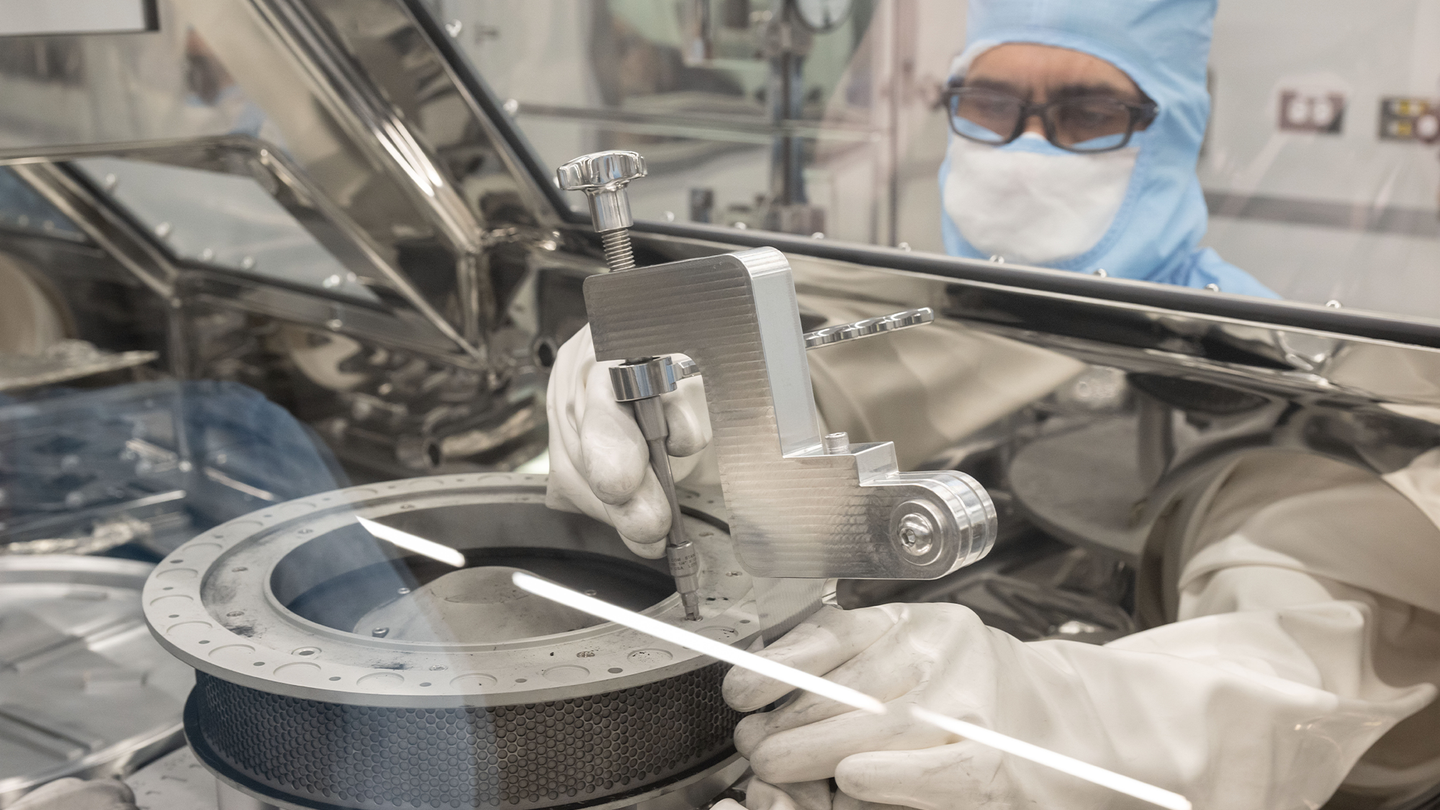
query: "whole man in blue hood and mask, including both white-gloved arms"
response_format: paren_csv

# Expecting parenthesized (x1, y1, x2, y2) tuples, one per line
(547, 0, 1440, 810)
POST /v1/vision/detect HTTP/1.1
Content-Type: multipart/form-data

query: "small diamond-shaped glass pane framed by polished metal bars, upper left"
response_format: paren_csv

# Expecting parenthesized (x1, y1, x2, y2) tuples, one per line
(75, 157, 376, 300)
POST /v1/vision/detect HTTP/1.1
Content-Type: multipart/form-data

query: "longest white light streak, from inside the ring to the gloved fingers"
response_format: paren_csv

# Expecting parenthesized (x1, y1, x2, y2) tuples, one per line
(511, 571, 887, 715)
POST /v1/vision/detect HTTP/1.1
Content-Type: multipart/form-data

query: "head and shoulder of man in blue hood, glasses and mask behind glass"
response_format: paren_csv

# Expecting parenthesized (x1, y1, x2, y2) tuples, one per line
(940, 0, 1276, 298)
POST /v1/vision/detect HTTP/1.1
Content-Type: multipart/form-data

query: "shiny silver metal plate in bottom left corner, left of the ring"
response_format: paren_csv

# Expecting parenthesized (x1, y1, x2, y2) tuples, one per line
(0, 555, 192, 807)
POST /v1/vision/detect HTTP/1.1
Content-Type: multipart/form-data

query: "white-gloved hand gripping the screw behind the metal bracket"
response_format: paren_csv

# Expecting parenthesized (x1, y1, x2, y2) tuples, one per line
(546, 326, 711, 559)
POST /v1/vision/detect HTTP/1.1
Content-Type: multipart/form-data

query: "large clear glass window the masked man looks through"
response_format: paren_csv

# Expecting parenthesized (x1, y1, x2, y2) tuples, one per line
(429, 0, 1440, 317)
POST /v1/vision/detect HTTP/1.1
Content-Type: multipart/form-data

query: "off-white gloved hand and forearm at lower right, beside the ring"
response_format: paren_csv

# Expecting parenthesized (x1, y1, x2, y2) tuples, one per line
(724, 601, 1434, 810)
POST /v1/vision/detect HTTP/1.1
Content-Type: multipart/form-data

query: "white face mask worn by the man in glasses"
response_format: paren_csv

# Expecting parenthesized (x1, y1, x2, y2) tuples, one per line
(943, 133, 1139, 265)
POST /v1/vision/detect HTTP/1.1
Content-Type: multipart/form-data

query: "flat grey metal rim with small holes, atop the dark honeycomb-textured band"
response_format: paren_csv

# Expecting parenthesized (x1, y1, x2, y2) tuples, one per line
(143, 473, 759, 708)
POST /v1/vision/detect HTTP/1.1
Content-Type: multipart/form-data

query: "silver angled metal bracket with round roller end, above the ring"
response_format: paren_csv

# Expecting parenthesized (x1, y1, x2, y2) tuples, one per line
(585, 248, 996, 579)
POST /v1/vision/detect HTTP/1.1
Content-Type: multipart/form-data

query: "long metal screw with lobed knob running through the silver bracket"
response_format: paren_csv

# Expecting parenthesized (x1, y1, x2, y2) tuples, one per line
(554, 151, 700, 621)
